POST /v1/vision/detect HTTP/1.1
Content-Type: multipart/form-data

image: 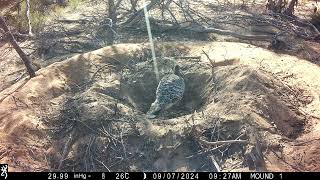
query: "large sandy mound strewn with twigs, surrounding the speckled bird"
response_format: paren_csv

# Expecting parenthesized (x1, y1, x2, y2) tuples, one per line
(0, 42, 320, 171)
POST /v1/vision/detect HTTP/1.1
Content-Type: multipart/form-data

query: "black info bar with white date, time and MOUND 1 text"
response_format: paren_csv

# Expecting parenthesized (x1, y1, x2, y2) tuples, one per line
(0, 172, 320, 180)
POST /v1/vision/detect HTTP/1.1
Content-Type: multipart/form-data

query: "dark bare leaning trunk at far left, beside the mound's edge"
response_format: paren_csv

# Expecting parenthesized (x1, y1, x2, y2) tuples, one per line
(0, 16, 36, 78)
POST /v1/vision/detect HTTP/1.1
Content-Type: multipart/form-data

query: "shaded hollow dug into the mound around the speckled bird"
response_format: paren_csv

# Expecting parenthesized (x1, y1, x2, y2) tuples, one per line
(120, 58, 212, 119)
